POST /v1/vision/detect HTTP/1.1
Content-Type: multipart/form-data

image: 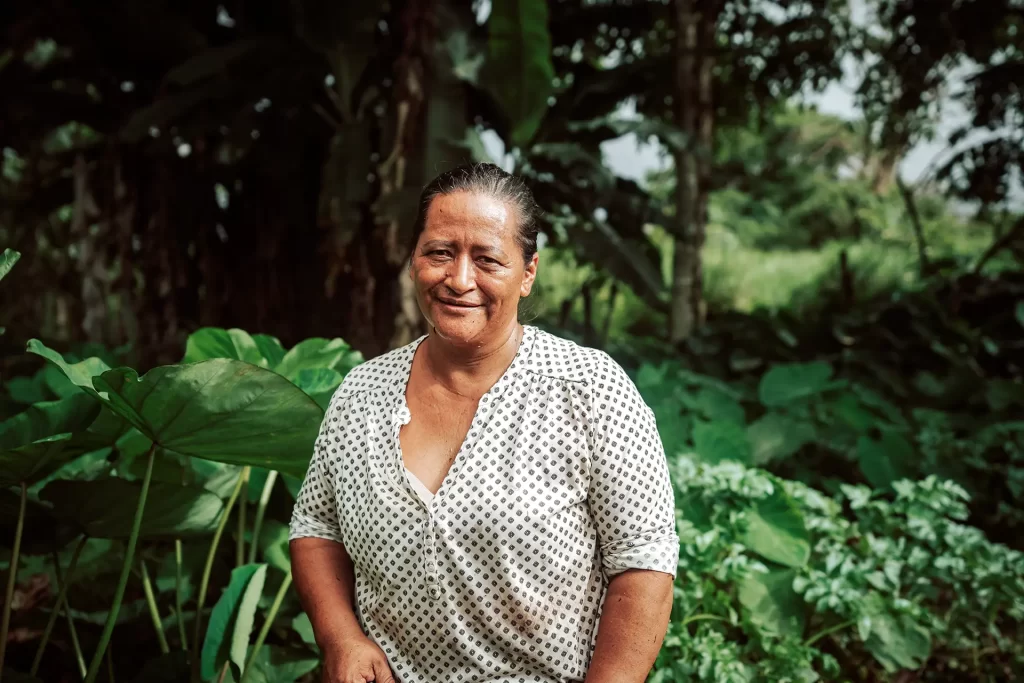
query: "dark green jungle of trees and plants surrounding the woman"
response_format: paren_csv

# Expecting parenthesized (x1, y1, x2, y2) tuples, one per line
(0, 0, 1024, 683)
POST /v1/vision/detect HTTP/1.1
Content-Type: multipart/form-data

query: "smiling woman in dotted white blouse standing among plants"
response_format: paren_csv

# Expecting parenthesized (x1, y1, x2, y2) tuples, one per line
(291, 164, 679, 683)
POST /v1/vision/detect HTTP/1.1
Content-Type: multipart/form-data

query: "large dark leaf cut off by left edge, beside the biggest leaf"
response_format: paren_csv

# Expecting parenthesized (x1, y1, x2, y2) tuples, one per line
(0, 391, 104, 486)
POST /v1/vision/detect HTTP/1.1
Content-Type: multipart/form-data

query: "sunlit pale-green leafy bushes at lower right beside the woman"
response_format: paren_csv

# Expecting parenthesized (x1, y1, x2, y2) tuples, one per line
(651, 455, 1024, 681)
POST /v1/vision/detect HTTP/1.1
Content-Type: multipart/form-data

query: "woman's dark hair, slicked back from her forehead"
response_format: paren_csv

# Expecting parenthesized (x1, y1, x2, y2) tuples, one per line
(412, 164, 541, 262)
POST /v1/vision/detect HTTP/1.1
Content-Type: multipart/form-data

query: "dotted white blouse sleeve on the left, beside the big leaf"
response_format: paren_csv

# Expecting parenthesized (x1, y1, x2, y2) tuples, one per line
(289, 387, 343, 543)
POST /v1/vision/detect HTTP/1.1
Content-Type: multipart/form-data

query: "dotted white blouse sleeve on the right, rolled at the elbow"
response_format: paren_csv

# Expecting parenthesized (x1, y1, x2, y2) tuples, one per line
(589, 352, 679, 578)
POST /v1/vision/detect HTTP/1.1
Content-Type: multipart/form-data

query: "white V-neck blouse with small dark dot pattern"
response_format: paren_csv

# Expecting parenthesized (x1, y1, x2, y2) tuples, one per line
(291, 326, 679, 683)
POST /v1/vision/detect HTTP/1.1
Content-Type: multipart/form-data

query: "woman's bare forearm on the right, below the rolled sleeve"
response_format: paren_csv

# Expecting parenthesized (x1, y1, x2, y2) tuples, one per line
(585, 569, 673, 683)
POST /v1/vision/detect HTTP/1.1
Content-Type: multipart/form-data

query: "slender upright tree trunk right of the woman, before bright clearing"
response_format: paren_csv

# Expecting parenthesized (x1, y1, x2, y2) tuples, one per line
(669, 0, 719, 343)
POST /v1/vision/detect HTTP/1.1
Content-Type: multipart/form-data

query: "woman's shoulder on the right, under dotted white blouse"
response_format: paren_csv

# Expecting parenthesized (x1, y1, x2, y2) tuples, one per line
(529, 329, 632, 390)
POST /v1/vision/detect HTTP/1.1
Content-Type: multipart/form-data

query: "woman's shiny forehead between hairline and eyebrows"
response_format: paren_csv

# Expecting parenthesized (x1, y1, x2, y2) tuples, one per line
(424, 191, 516, 241)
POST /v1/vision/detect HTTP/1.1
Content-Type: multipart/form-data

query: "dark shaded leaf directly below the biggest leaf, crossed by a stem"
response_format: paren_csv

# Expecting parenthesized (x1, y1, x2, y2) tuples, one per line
(40, 477, 223, 539)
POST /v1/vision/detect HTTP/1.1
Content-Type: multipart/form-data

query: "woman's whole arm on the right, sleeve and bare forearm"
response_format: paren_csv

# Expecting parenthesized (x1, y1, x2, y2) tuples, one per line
(586, 358, 679, 683)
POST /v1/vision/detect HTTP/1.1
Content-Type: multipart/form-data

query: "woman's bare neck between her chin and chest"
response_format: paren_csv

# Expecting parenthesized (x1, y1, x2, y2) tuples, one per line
(424, 319, 525, 398)
